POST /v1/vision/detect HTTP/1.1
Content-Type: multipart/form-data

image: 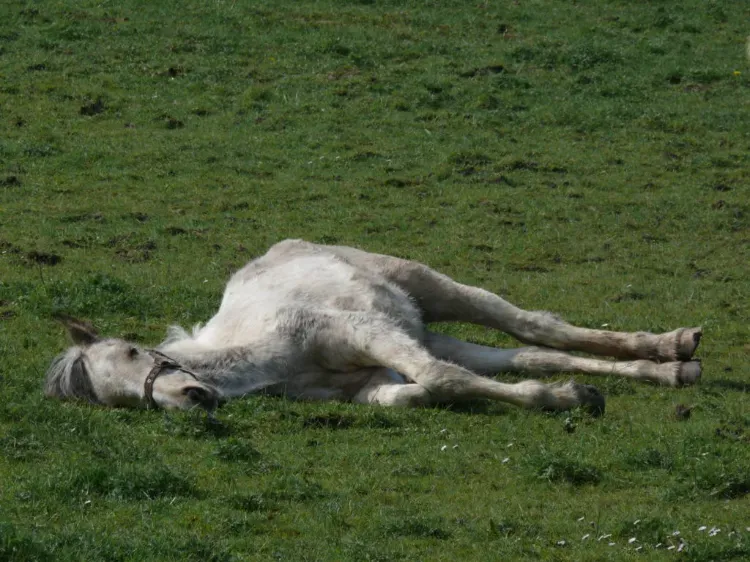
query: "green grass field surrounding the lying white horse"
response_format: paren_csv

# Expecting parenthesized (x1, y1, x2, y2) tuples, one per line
(0, 0, 750, 561)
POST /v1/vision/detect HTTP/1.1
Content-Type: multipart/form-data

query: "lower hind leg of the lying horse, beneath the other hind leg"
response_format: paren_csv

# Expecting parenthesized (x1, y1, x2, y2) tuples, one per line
(425, 332, 701, 386)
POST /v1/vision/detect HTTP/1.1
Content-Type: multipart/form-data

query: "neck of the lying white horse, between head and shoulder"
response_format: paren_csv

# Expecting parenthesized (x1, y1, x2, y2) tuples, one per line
(161, 345, 286, 398)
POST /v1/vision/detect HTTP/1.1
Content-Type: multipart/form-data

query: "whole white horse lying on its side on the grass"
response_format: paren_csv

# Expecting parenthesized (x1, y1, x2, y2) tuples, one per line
(45, 240, 701, 414)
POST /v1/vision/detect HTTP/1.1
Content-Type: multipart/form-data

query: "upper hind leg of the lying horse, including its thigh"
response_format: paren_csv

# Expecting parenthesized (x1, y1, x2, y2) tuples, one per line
(327, 246, 701, 361)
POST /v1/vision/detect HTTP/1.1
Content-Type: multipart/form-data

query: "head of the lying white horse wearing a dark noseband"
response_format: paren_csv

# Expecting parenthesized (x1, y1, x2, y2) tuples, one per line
(45, 316, 219, 411)
